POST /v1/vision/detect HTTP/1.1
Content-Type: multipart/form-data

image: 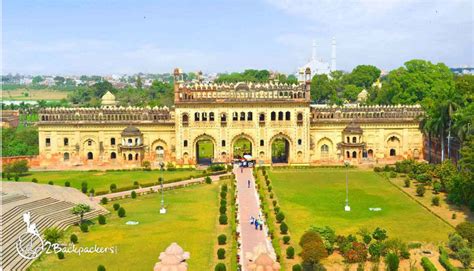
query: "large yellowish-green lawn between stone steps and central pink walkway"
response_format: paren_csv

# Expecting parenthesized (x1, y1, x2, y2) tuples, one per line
(31, 183, 219, 271)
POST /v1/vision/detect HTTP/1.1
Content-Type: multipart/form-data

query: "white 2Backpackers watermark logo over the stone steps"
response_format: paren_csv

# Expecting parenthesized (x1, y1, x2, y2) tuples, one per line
(16, 212, 118, 260)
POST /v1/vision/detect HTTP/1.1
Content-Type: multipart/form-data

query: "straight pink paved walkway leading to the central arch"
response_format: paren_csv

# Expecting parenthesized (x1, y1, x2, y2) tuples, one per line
(234, 168, 274, 271)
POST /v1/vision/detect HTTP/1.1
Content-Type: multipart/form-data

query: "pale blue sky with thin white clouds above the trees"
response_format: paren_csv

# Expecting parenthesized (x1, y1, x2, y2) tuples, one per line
(2, 0, 474, 75)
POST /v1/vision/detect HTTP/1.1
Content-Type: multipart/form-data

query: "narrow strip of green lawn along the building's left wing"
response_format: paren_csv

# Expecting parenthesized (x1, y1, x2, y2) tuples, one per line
(6, 170, 201, 192)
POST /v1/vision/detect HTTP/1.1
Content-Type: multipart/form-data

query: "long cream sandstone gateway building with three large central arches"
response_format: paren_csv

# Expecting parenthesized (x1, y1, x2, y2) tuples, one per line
(36, 69, 423, 168)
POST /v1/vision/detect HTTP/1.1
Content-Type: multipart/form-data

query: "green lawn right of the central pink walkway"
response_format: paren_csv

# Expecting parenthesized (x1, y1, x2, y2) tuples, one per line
(269, 169, 454, 242)
